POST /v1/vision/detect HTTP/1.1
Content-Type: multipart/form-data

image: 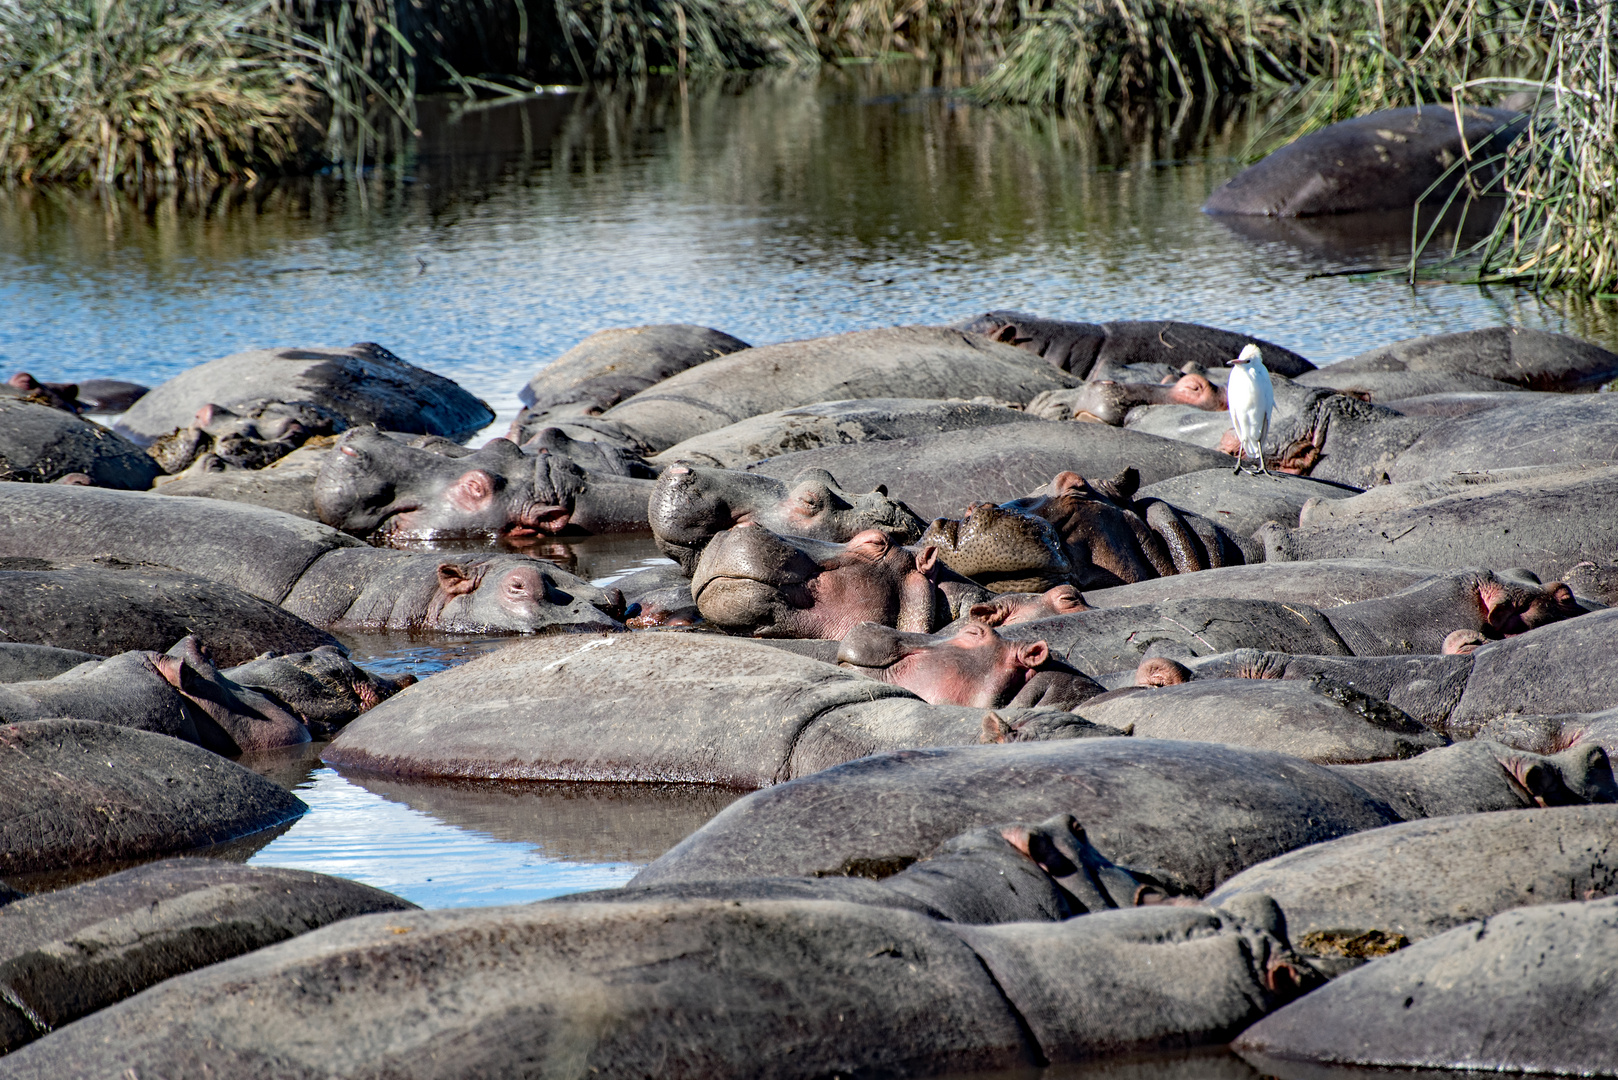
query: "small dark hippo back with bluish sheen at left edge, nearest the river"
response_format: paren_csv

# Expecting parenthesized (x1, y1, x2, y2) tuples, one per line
(0, 397, 163, 491)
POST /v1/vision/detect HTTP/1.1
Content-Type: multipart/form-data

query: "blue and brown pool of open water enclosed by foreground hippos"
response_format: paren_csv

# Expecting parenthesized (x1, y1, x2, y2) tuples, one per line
(239, 743, 741, 907)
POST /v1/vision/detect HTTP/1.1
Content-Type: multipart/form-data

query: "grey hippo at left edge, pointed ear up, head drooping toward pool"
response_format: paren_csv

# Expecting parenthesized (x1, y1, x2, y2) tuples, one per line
(0, 638, 320, 756)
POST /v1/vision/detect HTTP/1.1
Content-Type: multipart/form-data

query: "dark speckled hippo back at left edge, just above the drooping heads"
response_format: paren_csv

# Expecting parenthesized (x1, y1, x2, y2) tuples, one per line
(0, 557, 337, 665)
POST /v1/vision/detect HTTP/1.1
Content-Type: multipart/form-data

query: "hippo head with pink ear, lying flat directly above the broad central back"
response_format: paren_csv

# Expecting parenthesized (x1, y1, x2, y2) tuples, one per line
(427, 555, 623, 633)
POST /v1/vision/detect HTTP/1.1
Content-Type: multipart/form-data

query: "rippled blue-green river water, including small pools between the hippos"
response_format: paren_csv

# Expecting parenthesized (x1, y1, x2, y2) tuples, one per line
(0, 65, 1618, 907)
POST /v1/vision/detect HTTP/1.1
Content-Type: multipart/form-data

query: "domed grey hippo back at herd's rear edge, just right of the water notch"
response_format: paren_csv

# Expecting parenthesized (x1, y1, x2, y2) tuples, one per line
(510, 324, 751, 445)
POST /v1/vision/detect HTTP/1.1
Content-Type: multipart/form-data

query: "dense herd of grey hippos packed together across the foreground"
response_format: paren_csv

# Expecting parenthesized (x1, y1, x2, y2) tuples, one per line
(0, 289, 1618, 1078)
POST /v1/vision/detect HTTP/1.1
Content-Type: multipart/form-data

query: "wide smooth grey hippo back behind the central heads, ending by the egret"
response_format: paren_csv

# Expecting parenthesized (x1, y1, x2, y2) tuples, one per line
(748, 421, 1230, 520)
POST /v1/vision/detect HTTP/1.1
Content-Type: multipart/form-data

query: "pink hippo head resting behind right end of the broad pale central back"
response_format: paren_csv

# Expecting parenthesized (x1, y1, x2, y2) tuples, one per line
(837, 622, 1102, 709)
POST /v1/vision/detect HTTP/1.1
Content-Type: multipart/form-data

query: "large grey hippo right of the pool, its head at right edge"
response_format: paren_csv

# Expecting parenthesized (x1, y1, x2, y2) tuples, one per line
(631, 738, 1612, 895)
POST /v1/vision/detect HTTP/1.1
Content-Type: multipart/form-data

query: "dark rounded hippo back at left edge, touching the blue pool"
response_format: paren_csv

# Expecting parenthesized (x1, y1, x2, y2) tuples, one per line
(0, 721, 307, 881)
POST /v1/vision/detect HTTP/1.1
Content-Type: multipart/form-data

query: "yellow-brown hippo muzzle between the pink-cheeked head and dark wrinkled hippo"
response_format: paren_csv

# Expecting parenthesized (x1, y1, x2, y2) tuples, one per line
(921, 502, 1073, 593)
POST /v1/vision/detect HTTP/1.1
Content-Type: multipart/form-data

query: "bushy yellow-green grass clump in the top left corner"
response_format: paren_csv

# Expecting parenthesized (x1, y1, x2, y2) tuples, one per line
(0, 0, 314, 183)
